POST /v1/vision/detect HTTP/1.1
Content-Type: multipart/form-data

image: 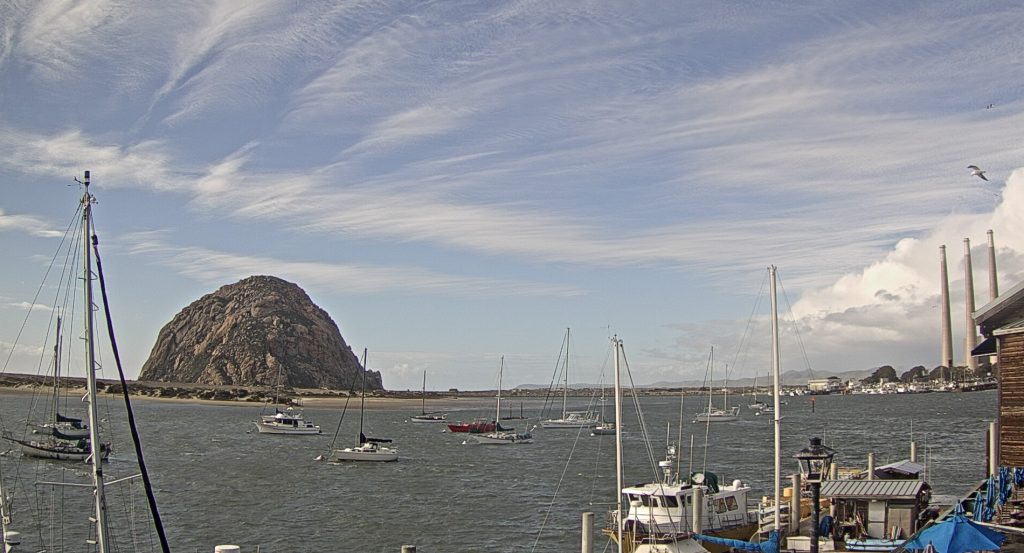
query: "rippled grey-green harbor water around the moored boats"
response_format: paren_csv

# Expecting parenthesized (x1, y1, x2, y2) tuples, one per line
(0, 391, 995, 553)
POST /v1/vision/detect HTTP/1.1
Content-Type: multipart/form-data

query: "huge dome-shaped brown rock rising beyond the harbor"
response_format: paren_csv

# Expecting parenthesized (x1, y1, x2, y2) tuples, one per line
(139, 277, 383, 390)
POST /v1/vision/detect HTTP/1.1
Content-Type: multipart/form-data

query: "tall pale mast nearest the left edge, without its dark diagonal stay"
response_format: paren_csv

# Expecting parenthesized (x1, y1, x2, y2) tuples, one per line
(82, 171, 108, 553)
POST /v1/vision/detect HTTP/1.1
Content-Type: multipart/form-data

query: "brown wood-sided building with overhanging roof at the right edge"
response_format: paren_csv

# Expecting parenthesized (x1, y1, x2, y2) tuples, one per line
(972, 283, 1024, 467)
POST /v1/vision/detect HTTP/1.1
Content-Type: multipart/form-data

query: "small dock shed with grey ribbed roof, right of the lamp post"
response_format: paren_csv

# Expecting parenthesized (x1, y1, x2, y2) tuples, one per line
(821, 479, 932, 542)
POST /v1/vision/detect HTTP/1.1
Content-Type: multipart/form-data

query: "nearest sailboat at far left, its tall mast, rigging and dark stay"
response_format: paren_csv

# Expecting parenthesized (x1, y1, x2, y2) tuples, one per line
(0, 171, 170, 553)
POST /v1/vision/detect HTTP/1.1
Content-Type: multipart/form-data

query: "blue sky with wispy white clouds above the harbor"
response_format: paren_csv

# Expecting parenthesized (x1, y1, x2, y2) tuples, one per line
(0, 0, 1024, 389)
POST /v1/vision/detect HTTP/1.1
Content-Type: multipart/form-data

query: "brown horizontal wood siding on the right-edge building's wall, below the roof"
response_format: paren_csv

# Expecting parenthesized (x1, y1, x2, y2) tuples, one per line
(999, 334, 1024, 467)
